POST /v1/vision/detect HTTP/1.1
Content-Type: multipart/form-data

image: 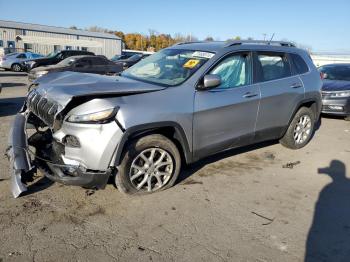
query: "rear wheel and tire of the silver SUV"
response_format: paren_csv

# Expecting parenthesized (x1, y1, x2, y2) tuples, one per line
(280, 107, 315, 149)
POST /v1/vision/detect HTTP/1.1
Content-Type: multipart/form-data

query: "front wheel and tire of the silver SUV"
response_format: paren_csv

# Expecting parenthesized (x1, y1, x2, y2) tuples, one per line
(115, 134, 181, 195)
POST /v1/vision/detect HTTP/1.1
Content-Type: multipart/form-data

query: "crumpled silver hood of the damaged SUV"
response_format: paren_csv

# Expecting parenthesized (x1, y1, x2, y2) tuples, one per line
(34, 71, 165, 109)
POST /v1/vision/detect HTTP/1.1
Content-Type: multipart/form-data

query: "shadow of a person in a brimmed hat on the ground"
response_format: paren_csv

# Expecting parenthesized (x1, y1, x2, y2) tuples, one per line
(305, 160, 350, 262)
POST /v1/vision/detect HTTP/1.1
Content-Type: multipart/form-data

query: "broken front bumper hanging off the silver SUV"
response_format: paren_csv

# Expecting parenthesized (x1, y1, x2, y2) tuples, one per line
(7, 113, 110, 197)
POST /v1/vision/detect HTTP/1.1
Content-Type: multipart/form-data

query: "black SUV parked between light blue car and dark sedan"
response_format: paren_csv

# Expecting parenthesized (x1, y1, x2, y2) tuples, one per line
(22, 50, 95, 72)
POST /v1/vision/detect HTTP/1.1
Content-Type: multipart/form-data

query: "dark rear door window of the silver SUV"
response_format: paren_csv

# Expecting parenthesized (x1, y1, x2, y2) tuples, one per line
(258, 53, 291, 81)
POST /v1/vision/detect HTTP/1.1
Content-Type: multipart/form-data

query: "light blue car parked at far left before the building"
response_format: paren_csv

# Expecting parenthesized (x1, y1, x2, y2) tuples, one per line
(0, 52, 43, 72)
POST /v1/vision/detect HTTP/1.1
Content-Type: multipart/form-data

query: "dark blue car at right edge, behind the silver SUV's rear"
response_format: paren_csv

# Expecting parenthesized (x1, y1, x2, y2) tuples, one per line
(318, 64, 350, 121)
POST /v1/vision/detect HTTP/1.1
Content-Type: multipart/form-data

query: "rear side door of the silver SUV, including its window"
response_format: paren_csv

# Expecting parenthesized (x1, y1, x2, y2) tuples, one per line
(254, 52, 304, 140)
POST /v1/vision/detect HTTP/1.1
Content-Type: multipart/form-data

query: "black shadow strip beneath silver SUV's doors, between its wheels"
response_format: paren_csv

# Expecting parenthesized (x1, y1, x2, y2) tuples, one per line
(176, 140, 279, 184)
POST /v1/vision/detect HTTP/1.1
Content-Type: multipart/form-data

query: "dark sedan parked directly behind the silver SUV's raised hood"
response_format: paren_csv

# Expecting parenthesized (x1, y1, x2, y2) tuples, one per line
(28, 55, 123, 82)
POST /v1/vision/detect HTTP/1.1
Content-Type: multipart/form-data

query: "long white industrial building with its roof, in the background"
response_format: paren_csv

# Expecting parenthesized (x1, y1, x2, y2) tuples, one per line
(0, 20, 122, 58)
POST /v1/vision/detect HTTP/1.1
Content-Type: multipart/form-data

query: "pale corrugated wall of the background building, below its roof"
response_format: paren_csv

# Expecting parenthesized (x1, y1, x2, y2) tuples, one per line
(0, 27, 122, 58)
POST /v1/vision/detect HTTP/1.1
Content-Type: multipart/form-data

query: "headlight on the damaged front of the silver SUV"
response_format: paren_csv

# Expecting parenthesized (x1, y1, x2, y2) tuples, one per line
(67, 108, 119, 124)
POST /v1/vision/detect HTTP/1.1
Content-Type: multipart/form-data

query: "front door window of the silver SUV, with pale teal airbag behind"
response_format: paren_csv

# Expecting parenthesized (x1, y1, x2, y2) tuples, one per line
(210, 54, 250, 88)
